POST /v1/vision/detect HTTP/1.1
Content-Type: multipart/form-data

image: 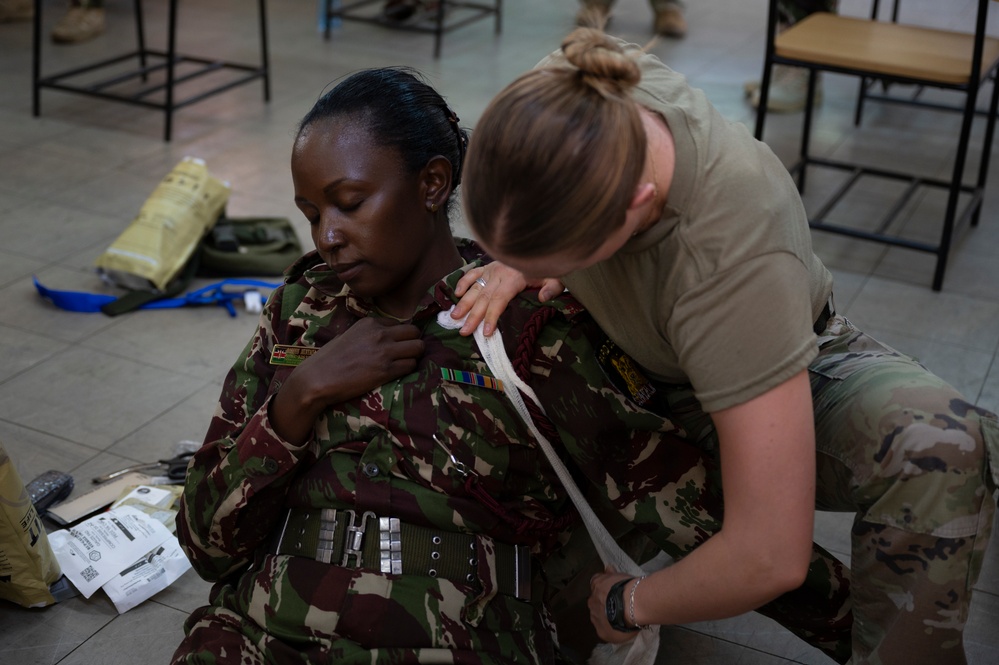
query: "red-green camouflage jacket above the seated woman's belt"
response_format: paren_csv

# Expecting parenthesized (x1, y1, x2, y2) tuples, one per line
(178, 242, 707, 660)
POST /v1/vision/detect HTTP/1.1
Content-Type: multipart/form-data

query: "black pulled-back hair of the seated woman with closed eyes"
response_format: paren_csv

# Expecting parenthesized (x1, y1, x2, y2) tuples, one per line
(298, 67, 468, 197)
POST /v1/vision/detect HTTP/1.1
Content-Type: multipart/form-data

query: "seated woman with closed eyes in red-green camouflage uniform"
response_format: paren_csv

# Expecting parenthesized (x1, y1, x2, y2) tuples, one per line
(173, 69, 732, 665)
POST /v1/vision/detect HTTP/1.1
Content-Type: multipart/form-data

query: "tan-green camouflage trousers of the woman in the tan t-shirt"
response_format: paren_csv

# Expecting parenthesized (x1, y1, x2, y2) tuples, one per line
(669, 316, 999, 665)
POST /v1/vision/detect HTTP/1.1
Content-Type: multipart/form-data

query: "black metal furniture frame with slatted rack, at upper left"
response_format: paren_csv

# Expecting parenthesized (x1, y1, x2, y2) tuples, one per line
(31, 0, 271, 141)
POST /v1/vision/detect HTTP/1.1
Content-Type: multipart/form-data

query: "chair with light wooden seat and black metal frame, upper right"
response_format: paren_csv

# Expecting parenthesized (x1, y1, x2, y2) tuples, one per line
(756, 0, 999, 291)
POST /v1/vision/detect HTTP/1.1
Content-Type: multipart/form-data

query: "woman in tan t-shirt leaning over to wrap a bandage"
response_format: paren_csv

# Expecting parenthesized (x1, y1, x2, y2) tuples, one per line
(454, 29, 999, 665)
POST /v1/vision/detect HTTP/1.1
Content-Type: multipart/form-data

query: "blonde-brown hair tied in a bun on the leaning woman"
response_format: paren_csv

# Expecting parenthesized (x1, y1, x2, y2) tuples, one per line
(462, 28, 646, 258)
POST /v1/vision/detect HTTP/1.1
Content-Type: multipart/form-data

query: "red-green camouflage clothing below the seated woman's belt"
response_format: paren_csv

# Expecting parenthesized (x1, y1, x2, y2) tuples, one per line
(171, 555, 558, 665)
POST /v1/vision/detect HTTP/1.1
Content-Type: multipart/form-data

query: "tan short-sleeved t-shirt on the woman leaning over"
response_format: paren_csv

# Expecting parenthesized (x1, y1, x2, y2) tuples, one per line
(539, 42, 832, 413)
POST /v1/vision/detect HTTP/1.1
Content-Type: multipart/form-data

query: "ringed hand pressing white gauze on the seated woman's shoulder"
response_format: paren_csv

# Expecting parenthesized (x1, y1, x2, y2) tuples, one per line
(451, 261, 565, 337)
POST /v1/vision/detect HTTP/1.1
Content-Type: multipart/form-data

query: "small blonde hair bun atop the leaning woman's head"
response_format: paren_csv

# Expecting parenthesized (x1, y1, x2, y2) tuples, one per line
(562, 28, 642, 95)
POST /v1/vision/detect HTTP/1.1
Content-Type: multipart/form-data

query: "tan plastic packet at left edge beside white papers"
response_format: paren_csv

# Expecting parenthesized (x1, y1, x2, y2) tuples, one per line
(0, 444, 62, 607)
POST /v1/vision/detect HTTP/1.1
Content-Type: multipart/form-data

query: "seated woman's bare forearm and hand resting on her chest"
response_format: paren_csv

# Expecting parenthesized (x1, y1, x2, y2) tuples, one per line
(270, 317, 424, 443)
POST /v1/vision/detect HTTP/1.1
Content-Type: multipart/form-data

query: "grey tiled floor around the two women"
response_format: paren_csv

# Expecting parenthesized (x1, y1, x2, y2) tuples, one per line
(0, 0, 999, 665)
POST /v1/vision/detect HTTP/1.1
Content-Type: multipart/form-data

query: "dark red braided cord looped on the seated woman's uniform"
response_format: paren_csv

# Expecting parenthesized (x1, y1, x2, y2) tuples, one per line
(465, 307, 578, 535)
